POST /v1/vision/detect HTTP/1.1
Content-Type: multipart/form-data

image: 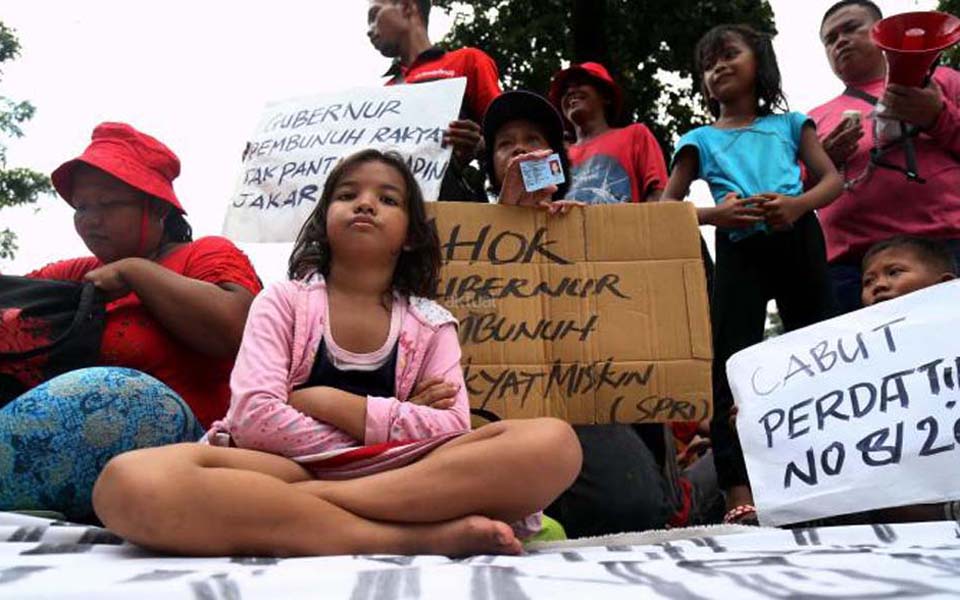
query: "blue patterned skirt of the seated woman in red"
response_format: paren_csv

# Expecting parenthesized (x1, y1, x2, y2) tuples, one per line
(0, 367, 203, 521)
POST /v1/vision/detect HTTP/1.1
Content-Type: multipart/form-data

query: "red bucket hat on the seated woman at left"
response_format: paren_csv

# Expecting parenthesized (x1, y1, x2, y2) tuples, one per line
(50, 123, 187, 214)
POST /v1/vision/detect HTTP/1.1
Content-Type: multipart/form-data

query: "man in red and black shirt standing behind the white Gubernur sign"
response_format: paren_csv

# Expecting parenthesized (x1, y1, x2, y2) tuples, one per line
(367, 0, 500, 202)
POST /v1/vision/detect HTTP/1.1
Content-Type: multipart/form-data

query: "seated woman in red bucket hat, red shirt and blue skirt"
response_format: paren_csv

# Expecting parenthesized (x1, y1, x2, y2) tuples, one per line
(0, 123, 261, 520)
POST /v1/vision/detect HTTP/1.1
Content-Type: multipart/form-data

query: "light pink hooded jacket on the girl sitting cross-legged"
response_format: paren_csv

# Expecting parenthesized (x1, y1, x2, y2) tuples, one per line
(211, 279, 470, 458)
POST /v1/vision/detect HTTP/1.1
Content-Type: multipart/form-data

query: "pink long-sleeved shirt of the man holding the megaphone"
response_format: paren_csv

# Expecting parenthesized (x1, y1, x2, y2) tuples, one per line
(810, 67, 960, 262)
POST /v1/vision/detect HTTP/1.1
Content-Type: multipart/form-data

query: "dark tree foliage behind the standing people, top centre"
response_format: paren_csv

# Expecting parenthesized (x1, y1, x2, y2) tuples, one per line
(434, 0, 775, 148)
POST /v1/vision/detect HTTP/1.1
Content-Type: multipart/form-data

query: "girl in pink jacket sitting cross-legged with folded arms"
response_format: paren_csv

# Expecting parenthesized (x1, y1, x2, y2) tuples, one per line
(94, 150, 581, 556)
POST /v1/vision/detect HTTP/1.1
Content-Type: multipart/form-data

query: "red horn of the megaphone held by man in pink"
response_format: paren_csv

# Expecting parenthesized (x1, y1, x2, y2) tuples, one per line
(870, 11, 960, 87)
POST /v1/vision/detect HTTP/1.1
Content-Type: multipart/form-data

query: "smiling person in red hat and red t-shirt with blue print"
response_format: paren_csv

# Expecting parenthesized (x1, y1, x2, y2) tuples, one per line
(550, 62, 667, 204)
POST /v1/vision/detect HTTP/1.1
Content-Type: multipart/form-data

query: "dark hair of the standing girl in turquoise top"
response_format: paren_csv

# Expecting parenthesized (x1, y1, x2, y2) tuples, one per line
(694, 25, 788, 119)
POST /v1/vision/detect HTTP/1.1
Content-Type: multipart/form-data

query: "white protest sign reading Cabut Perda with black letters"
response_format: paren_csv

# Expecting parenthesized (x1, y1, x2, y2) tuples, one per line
(727, 282, 960, 525)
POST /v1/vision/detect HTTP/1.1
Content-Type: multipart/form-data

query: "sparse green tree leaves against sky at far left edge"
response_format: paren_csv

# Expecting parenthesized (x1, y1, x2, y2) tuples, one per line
(0, 21, 52, 259)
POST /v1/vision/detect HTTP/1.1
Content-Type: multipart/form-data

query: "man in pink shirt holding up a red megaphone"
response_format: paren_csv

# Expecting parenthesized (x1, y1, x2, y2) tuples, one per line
(810, 0, 960, 312)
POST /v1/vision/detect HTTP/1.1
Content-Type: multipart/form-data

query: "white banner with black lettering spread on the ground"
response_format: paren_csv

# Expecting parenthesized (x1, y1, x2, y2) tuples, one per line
(0, 510, 960, 600)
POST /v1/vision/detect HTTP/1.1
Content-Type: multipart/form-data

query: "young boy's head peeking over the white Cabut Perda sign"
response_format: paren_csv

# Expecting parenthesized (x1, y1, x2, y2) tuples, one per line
(860, 235, 957, 306)
